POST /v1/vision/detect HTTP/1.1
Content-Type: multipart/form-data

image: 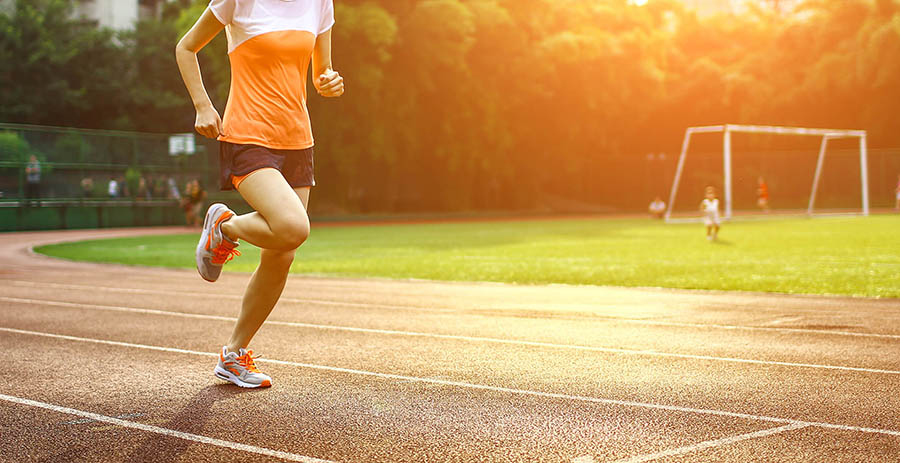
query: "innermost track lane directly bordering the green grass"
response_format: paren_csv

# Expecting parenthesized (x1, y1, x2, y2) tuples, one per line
(7, 272, 900, 339)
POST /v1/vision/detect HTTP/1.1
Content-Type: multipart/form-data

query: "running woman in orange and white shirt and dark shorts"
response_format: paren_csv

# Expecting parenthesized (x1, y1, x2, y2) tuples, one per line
(175, 0, 344, 387)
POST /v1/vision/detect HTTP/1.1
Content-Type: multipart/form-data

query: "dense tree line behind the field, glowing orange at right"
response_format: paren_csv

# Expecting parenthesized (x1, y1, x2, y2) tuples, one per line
(0, 0, 900, 211)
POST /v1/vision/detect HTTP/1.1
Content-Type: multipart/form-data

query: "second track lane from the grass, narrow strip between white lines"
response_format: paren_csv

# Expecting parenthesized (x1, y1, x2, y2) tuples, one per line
(0, 284, 900, 371)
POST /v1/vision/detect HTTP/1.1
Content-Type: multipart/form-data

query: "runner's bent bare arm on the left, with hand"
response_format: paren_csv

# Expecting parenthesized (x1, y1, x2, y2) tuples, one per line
(175, 8, 225, 138)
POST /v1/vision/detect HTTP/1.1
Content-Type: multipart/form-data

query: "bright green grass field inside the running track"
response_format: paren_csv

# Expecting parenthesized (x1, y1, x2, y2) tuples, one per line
(37, 215, 900, 297)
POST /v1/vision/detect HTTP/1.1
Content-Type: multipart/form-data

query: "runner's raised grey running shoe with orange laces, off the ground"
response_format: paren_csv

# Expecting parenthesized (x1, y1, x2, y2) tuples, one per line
(196, 203, 241, 282)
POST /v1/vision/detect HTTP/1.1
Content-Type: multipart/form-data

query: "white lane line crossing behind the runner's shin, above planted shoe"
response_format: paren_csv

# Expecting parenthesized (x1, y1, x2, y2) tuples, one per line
(0, 296, 900, 375)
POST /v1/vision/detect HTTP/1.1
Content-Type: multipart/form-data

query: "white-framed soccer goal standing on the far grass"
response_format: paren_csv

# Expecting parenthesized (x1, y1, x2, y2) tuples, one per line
(665, 124, 869, 222)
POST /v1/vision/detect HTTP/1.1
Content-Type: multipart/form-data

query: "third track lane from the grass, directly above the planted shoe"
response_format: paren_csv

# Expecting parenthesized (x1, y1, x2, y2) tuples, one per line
(0, 302, 900, 429)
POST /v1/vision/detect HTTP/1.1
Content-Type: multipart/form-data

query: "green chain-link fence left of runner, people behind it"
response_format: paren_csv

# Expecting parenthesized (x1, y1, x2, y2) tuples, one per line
(0, 124, 218, 231)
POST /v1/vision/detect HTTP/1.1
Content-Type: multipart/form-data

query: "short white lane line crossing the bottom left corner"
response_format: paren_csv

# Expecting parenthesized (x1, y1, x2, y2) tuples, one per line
(0, 394, 332, 463)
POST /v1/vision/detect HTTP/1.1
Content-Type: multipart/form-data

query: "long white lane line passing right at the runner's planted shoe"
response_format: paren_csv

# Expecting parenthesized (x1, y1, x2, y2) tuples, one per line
(0, 327, 900, 437)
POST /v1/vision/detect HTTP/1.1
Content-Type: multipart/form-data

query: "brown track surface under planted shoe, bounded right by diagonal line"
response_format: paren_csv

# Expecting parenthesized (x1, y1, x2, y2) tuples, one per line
(0, 337, 769, 461)
